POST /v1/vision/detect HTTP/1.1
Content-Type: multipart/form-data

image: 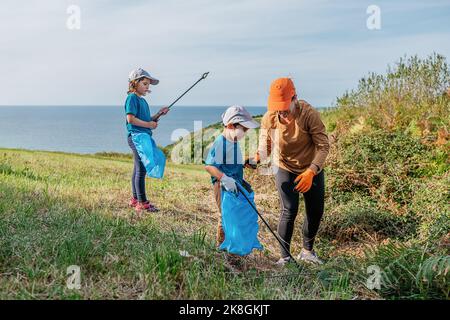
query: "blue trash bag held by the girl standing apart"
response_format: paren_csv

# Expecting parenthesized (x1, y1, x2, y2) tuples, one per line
(131, 133, 166, 179)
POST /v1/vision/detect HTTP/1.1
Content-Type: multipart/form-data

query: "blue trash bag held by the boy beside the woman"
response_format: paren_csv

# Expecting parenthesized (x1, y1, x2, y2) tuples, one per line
(219, 182, 263, 256)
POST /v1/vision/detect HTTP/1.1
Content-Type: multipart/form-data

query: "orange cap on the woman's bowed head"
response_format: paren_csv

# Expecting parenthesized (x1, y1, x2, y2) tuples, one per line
(268, 78, 296, 111)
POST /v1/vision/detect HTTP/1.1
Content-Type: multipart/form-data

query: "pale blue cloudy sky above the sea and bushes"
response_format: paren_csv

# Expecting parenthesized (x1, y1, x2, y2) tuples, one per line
(0, 0, 450, 106)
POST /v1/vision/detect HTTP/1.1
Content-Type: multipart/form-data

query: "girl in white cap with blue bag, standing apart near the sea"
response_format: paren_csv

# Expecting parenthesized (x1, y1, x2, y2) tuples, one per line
(125, 68, 169, 214)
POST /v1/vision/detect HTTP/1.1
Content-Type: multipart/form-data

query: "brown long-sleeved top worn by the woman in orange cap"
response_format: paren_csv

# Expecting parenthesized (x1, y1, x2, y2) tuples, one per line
(258, 100, 330, 174)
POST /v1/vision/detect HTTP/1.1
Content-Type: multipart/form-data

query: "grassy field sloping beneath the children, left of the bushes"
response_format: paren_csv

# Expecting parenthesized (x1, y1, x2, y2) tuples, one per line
(0, 149, 356, 299)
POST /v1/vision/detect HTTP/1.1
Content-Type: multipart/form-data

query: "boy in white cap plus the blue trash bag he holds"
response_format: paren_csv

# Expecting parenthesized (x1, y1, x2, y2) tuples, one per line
(205, 106, 262, 256)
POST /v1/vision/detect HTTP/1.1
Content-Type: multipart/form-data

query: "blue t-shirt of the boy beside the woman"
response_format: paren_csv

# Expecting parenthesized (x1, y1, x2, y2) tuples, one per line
(205, 135, 244, 184)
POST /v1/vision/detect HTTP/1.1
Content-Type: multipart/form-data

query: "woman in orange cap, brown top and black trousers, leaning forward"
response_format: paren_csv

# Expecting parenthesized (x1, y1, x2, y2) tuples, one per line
(255, 78, 329, 265)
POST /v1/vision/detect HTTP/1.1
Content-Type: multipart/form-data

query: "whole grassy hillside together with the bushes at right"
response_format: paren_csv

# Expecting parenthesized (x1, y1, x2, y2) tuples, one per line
(0, 55, 450, 299)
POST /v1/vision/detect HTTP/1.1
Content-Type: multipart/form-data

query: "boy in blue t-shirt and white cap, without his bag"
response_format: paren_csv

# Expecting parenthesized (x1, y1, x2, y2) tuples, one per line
(205, 106, 259, 246)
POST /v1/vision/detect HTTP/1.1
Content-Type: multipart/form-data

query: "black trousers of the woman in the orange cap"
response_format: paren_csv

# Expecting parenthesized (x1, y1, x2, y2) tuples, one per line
(276, 168, 325, 258)
